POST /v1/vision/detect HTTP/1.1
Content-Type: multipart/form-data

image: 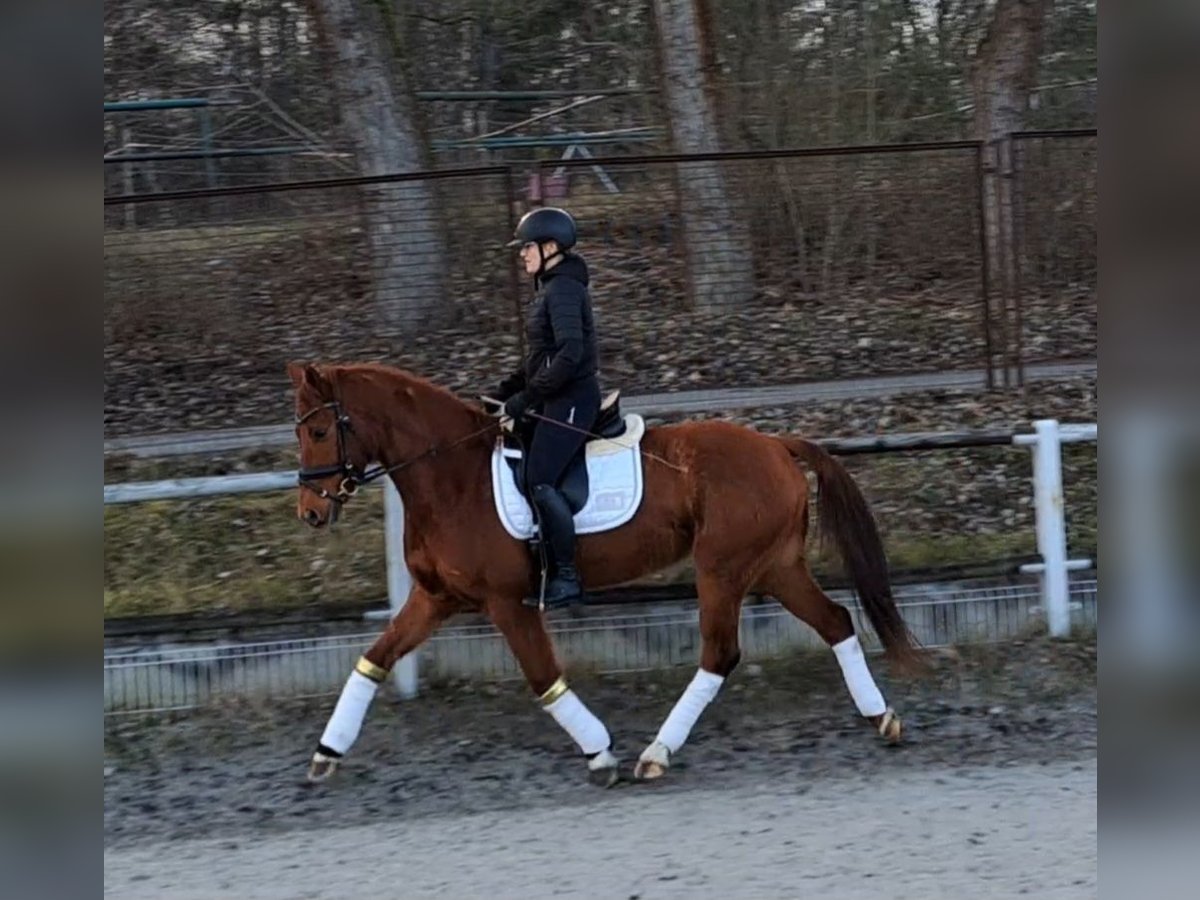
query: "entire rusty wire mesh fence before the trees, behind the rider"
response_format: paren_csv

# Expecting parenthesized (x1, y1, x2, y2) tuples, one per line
(104, 132, 1096, 436)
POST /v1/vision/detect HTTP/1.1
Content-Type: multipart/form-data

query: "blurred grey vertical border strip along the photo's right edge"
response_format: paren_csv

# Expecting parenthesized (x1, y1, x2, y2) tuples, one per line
(1098, 0, 1200, 896)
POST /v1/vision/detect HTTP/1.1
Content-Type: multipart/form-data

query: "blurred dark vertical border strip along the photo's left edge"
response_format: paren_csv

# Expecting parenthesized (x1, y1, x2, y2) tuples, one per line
(0, 0, 103, 898)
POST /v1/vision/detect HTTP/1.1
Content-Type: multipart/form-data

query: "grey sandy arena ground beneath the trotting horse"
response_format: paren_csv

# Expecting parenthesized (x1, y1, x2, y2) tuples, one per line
(104, 640, 1097, 900)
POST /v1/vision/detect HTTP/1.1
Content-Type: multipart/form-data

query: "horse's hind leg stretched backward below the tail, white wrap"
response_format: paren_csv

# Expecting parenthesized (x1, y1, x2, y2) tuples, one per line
(756, 559, 901, 743)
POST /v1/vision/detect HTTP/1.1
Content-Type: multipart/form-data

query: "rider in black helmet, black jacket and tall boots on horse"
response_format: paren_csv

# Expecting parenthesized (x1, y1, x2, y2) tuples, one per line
(497, 206, 600, 608)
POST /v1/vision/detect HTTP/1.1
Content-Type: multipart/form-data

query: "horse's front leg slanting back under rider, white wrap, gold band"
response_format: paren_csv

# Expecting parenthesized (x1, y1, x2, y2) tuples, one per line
(487, 598, 618, 787)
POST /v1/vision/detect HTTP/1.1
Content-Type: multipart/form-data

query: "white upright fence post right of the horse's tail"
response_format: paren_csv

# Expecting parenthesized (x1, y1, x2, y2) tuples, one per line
(1033, 419, 1070, 637)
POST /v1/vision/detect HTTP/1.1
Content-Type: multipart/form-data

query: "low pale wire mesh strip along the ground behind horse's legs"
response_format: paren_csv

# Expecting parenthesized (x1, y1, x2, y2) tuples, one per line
(104, 577, 1097, 714)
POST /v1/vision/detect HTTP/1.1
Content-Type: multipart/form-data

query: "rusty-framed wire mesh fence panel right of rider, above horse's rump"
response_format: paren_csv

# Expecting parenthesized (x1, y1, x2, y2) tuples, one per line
(541, 142, 985, 391)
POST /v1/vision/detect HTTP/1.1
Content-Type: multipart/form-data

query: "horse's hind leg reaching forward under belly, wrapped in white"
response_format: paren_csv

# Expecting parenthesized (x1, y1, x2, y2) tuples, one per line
(634, 572, 745, 780)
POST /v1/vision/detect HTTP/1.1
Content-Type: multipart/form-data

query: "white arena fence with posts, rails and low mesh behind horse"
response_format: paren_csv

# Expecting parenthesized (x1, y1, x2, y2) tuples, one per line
(104, 420, 1098, 709)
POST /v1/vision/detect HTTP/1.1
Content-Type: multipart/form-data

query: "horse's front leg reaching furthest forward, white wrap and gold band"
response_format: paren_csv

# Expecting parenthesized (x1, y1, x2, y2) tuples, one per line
(308, 587, 448, 781)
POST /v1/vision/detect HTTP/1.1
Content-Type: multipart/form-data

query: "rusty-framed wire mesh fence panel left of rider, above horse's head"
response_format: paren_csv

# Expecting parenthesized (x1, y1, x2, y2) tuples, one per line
(104, 169, 520, 439)
